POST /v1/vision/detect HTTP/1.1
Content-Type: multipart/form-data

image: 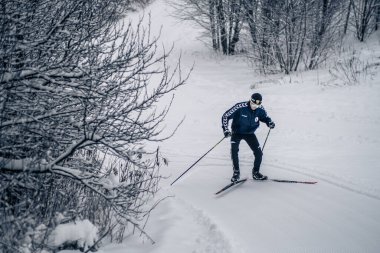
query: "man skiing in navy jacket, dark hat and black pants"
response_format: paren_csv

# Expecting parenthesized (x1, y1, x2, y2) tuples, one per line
(222, 93, 275, 182)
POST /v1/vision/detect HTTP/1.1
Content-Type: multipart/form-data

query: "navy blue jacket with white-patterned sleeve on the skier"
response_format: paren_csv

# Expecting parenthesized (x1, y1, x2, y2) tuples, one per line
(222, 102, 272, 134)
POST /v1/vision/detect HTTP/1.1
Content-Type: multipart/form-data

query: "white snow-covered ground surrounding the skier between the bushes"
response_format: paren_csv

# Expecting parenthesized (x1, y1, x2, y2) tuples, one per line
(59, 0, 380, 253)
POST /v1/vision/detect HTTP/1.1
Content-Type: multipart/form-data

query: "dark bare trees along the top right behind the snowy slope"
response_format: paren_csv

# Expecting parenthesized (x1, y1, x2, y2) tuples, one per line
(173, 0, 380, 74)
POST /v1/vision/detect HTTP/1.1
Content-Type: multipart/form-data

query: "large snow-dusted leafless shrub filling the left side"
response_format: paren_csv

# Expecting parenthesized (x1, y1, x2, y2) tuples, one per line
(0, 0, 186, 252)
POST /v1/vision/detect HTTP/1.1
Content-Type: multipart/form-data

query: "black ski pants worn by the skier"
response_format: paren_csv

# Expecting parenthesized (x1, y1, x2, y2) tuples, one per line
(231, 134, 263, 173)
